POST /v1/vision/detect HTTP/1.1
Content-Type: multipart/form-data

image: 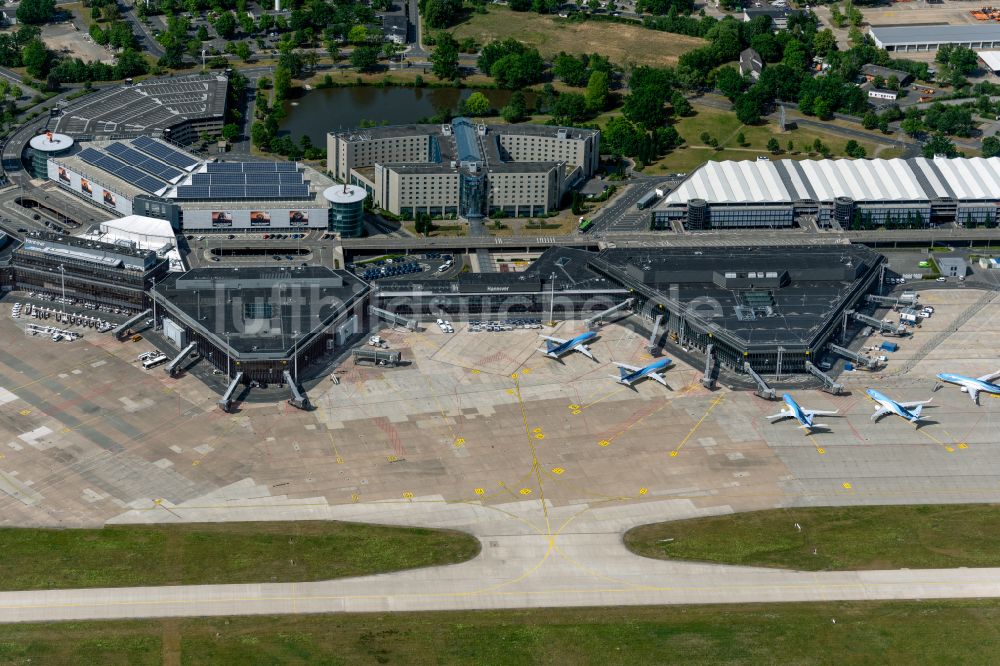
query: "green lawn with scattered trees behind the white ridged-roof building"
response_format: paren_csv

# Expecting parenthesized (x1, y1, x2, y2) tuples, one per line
(646, 101, 902, 173)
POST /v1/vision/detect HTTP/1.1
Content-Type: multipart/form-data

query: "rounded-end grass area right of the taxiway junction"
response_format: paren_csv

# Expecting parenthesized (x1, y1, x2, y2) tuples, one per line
(625, 504, 1000, 571)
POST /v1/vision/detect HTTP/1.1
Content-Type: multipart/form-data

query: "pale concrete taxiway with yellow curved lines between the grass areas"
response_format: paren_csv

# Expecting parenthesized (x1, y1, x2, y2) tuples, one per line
(0, 498, 1000, 622)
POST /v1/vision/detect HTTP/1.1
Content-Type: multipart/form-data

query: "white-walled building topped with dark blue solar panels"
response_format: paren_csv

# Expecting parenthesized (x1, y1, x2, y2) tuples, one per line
(46, 136, 363, 236)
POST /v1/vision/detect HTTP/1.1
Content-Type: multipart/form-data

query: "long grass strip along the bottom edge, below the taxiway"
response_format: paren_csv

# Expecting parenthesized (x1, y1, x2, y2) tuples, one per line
(0, 600, 1000, 666)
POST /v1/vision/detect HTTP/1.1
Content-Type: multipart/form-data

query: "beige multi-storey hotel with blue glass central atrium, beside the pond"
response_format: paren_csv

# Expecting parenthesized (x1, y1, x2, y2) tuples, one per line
(327, 118, 600, 219)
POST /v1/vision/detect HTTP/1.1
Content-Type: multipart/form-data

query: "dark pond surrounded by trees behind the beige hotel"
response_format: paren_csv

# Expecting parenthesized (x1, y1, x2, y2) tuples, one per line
(279, 86, 534, 146)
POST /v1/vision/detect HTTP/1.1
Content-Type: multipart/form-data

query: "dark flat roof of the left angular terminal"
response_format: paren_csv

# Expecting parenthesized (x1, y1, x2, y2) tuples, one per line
(156, 266, 367, 354)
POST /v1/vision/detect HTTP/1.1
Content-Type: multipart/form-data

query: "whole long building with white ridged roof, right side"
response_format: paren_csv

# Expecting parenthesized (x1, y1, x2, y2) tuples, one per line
(651, 157, 1000, 231)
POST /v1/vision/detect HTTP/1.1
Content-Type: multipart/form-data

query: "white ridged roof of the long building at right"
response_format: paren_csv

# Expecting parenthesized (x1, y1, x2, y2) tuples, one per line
(660, 157, 1000, 206)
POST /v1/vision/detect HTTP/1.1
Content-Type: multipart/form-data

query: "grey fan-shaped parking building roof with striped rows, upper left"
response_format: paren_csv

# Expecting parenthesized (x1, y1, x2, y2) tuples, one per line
(49, 74, 228, 137)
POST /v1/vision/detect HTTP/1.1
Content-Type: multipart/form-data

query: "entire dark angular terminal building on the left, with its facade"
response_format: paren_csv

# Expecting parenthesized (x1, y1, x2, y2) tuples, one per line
(152, 266, 369, 384)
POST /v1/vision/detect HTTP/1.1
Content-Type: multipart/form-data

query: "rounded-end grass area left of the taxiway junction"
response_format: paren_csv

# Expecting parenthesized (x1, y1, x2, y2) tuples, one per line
(0, 521, 479, 588)
